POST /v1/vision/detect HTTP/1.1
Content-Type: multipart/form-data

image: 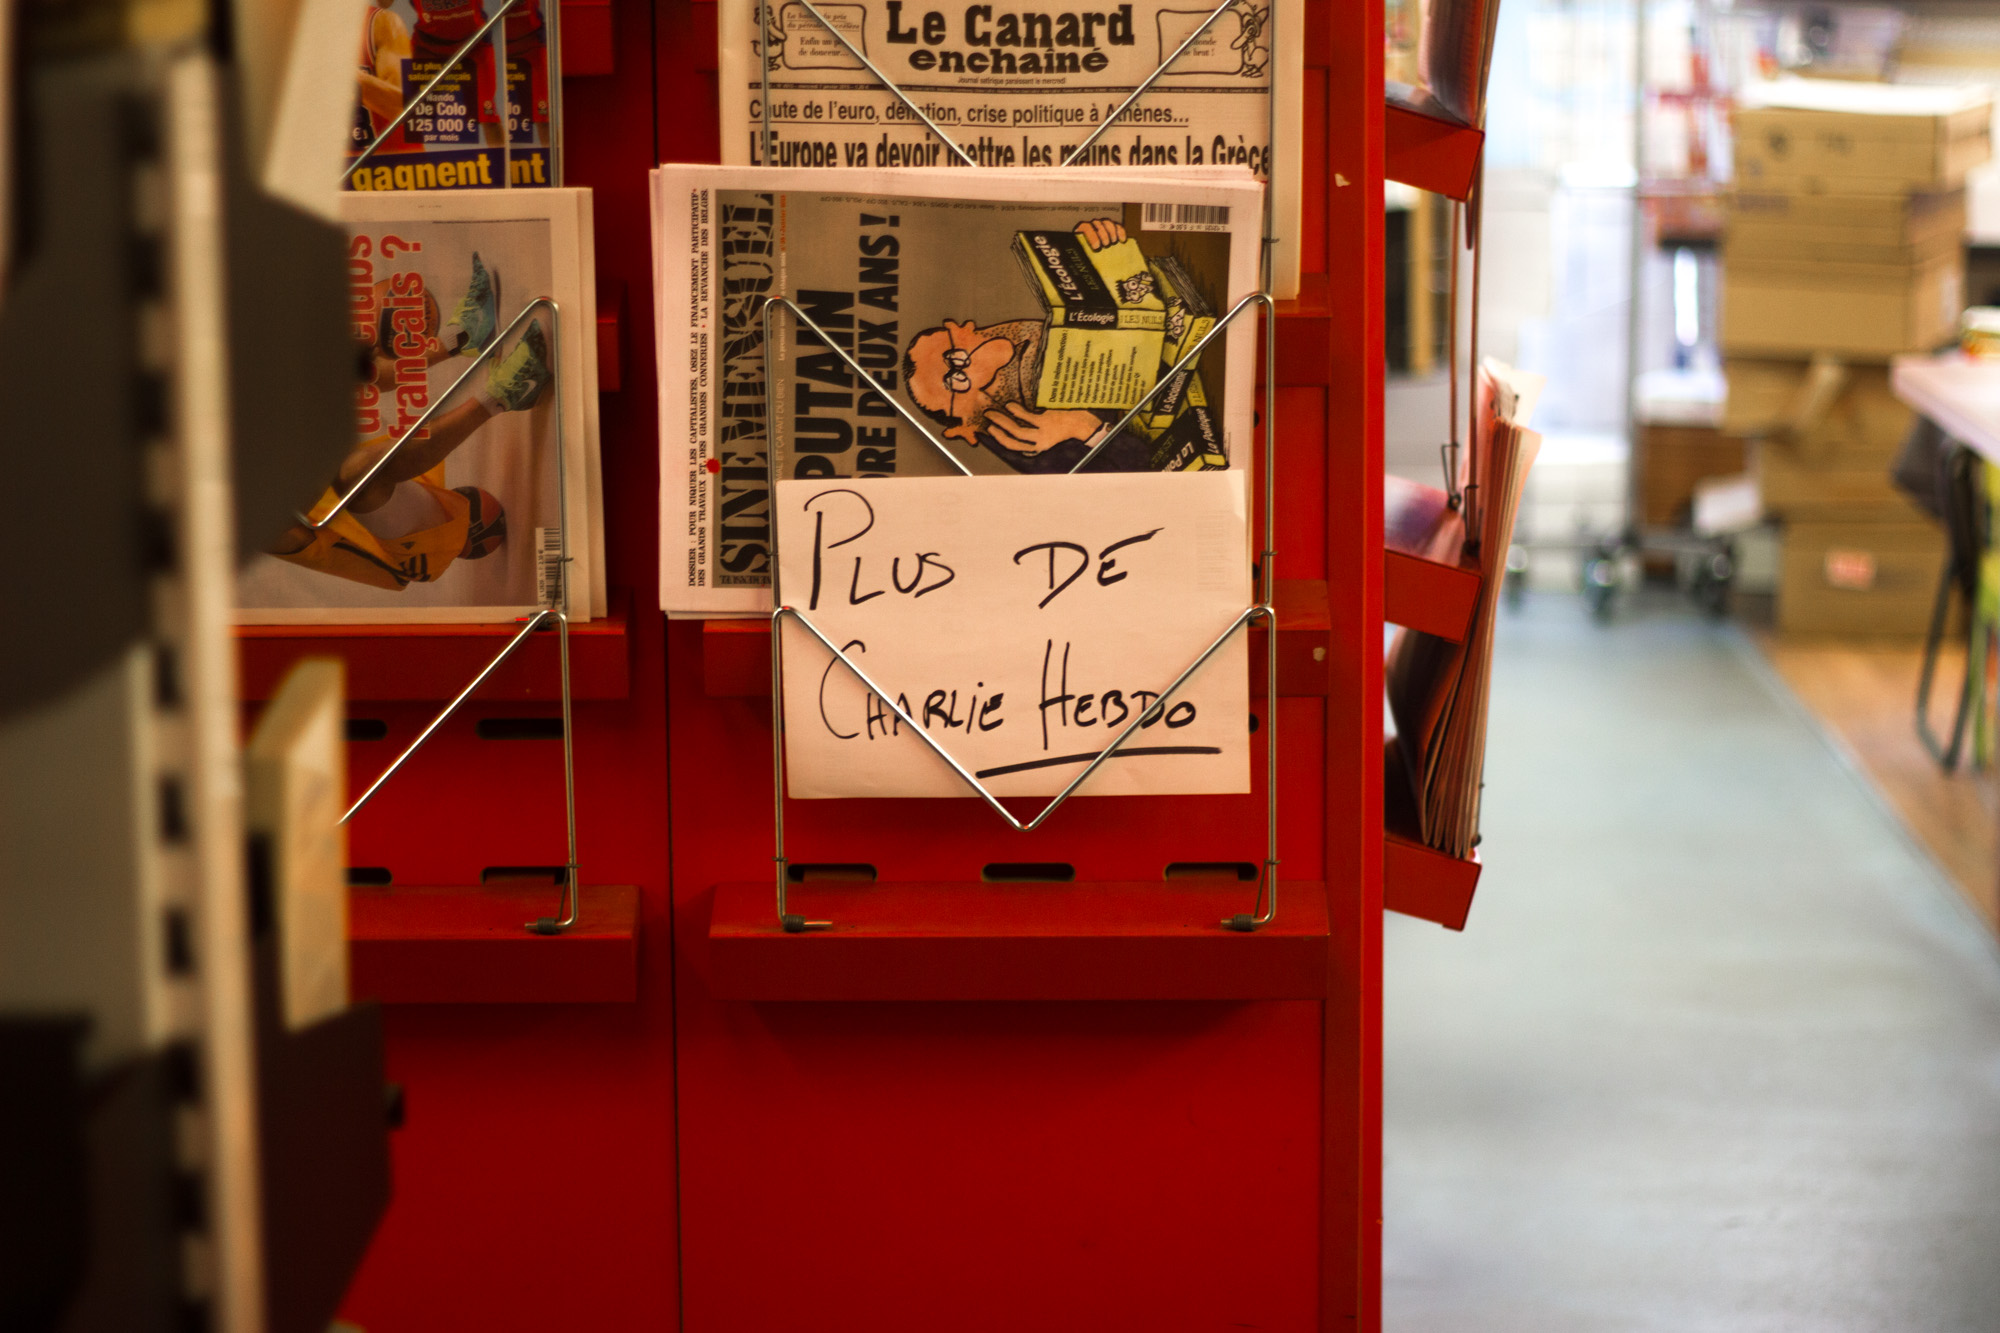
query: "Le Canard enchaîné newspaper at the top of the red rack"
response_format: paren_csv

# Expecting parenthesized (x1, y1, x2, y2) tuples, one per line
(718, 0, 1306, 298)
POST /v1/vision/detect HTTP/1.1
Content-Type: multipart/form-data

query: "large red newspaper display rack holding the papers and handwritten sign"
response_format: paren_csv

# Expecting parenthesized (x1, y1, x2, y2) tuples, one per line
(332, 0, 1384, 1331)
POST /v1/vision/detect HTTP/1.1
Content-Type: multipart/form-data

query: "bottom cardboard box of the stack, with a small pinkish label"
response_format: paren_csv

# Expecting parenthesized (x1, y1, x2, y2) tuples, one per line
(1778, 522, 1944, 636)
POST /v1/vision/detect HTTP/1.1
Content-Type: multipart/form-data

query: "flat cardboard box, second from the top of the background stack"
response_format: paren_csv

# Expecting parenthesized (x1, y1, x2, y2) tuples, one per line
(1722, 190, 1966, 264)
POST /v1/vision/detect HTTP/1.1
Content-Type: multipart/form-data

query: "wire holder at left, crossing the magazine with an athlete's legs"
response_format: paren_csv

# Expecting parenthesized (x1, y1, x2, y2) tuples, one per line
(310, 296, 578, 935)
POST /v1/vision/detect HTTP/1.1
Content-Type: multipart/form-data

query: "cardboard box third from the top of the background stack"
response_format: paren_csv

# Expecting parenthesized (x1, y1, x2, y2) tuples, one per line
(1722, 250, 1966, 360)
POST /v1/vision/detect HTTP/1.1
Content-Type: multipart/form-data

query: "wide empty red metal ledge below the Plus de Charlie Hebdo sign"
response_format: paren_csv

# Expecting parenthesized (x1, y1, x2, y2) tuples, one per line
(698, 879, 1330, 1001)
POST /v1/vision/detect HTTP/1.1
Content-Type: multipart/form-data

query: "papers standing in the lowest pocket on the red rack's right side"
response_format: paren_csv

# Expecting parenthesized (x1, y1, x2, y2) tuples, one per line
(1386, 358, 1542, 857)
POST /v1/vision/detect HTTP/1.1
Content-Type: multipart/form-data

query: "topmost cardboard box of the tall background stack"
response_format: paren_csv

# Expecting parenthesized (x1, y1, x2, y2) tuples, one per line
(1736, 78, 1992, 194)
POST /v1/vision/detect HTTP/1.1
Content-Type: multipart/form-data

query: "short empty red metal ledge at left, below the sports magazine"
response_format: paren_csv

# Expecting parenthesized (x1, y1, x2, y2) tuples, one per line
(348, 885, 638, 1005)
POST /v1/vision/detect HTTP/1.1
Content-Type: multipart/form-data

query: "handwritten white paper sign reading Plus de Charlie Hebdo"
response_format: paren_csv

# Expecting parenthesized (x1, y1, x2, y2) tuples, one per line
(778, 472, 1250, 797)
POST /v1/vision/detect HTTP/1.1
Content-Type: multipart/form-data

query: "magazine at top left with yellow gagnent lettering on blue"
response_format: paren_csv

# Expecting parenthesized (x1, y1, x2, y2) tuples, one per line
(346, 0, 558, 190)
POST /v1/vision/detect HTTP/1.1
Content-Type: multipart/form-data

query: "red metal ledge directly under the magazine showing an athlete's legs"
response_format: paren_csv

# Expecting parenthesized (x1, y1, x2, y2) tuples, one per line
(236, 588, 632, 703)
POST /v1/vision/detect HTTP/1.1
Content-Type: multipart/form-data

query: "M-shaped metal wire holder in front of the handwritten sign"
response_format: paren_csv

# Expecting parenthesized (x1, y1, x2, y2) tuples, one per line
(764, 292, 1278, 935)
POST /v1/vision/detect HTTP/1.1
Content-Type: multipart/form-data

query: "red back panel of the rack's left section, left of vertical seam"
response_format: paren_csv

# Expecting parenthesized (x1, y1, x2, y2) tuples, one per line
(342, 0, 684, 1333)
